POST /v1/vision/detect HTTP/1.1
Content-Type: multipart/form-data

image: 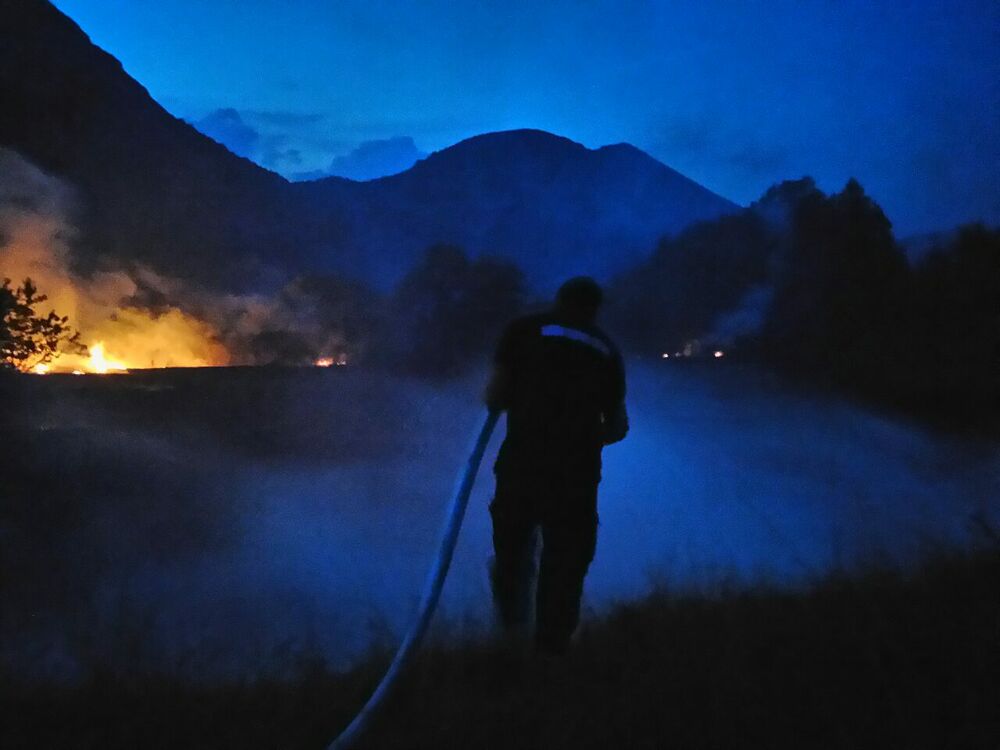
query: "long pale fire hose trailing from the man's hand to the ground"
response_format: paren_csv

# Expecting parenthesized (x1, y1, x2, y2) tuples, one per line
(327, 411, 500, 750)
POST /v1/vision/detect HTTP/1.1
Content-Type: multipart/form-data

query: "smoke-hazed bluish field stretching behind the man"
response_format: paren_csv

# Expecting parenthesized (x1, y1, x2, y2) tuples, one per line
(0, 360, 1000, 682)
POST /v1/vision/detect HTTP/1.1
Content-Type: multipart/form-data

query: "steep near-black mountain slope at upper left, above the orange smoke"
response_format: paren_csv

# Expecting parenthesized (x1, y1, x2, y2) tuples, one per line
(0, 0, 304, 286)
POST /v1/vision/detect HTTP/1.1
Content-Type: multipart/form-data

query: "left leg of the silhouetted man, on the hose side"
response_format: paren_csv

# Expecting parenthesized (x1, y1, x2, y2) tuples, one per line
(490, 477, 537, 630)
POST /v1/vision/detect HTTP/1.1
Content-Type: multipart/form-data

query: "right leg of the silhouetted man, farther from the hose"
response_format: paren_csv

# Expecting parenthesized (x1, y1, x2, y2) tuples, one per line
(535, 488, 597, 654)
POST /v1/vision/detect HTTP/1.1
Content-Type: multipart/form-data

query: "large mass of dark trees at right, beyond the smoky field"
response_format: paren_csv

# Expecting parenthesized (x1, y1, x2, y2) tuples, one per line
(609, 178, 1000, 434)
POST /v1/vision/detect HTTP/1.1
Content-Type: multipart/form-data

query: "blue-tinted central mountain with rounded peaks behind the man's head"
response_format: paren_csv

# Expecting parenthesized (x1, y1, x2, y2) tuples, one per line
(292, 130, 736, 286)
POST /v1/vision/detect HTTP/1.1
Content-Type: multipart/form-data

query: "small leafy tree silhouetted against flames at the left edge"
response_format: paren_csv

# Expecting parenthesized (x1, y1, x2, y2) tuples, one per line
(0, 278, 86, 372)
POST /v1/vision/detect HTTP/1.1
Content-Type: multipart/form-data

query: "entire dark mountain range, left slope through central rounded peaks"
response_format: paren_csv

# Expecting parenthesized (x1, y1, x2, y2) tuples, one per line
(0, 0, 736, 288)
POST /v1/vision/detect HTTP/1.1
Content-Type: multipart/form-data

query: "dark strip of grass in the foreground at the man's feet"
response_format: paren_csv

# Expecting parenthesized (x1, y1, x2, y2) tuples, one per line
(0, 547, 1000, 750)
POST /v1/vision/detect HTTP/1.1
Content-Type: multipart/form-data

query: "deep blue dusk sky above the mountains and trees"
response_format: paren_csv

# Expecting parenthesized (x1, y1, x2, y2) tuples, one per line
(55, 0, 1000, 236)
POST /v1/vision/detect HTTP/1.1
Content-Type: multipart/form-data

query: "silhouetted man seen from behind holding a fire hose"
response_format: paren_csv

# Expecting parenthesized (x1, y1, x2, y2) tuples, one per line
(486, 277, 628, 653)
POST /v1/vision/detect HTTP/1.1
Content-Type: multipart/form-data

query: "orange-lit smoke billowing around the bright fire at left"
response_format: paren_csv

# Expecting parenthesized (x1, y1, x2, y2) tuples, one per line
(0, 148, 360, 371)
